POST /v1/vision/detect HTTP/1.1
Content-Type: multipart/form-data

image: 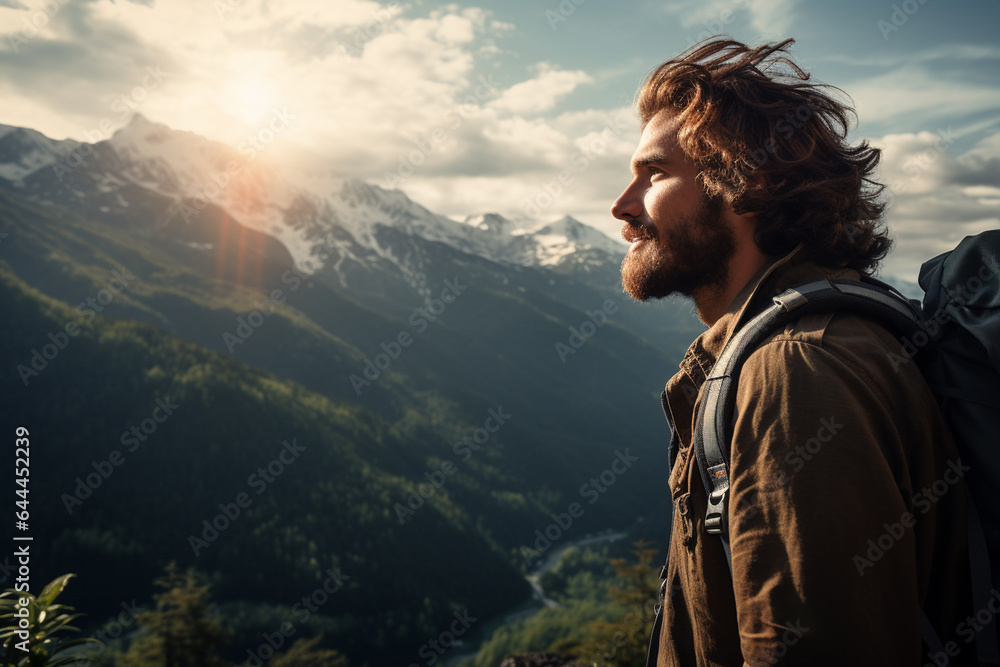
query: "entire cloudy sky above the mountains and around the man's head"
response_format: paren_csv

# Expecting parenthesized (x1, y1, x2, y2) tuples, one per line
(0, 0, 1000, 281)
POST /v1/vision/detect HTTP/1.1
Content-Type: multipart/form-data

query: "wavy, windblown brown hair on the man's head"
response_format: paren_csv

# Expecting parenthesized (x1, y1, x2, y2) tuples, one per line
(637, 37, 892, 275)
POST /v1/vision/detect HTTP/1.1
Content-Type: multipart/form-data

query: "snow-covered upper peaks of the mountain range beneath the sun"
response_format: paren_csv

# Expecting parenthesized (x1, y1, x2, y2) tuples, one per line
(0, 114, 625, 282)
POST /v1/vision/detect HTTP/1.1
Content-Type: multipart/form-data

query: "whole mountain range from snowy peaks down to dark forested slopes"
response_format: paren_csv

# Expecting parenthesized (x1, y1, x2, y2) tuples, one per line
(0, 116, 701, 664)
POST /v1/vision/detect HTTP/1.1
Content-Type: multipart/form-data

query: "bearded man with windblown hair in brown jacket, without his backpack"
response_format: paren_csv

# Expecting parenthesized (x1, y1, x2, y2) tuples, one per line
(612, 40, 973, 666)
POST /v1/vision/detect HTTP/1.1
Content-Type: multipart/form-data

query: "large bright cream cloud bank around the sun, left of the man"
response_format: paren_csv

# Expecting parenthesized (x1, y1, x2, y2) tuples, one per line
(0, 0, 637, 235)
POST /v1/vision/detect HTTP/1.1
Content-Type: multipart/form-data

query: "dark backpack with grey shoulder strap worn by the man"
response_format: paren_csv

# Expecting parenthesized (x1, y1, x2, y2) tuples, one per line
(647, 230, 1000, 667)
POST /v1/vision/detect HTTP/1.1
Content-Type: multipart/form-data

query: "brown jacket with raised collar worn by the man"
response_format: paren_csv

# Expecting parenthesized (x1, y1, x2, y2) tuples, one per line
(658, 250, 973, 667)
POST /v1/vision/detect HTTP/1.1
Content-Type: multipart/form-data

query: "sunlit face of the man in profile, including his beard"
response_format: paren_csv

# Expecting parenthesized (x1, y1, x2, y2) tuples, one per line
(611, 111, 736, 301)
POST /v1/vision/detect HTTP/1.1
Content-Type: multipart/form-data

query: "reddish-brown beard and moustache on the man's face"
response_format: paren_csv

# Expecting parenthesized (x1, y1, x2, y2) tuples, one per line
(622, 197, 736, 301)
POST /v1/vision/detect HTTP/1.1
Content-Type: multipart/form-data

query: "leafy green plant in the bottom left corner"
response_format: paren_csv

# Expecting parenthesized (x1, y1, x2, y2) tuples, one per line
(0, 574, 97, 667)
